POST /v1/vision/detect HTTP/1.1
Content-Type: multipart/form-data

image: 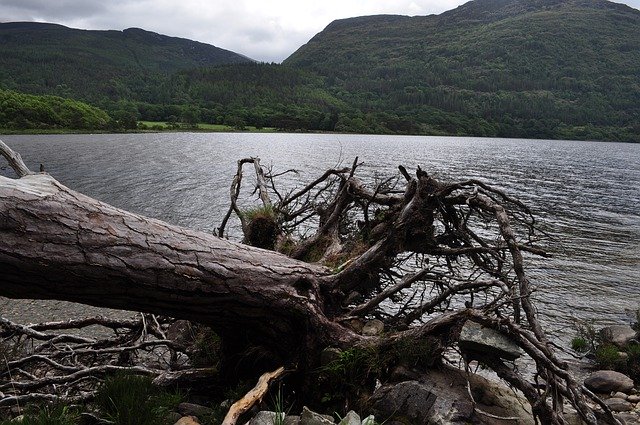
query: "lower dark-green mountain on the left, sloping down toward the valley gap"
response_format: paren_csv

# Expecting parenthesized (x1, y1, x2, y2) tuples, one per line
(0, 22, 253, 102)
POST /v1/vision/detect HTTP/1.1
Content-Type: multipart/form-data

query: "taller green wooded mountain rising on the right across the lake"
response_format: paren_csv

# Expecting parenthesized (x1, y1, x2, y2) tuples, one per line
(283, 0, 640, 141)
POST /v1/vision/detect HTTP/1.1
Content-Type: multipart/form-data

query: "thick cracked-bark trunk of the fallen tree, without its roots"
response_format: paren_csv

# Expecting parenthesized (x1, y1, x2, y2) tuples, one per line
(0, 174, 357, 358)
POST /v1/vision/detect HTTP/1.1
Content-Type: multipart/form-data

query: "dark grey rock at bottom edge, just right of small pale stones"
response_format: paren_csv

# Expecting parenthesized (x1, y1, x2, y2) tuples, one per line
(372, 381, 436, 424)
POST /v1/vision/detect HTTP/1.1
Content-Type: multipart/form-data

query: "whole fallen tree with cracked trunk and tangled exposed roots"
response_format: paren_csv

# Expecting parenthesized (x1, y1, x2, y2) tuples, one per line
(0, 142, 617, 424)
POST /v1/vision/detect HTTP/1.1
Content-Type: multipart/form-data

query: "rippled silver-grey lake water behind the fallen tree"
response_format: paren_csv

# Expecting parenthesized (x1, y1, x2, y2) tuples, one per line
(0, 133, 640, 342)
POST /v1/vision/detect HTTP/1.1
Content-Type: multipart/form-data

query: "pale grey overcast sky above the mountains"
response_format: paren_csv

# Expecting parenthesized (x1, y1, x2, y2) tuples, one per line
(0, 0, 640, 62)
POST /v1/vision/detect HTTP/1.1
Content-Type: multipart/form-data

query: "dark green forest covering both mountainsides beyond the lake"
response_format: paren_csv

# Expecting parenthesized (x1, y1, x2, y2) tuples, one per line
(0, 1, 640, 142)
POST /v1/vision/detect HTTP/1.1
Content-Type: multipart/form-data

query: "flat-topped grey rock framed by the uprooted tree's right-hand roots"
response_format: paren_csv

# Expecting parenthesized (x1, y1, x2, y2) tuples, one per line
(458, 321, 522, 360)
